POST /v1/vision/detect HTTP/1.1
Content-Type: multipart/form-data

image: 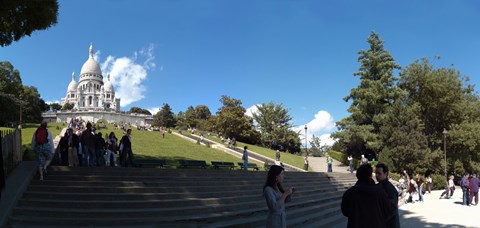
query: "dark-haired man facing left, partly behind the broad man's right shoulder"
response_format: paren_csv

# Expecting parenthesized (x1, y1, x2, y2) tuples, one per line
(375, 163, 400, 227)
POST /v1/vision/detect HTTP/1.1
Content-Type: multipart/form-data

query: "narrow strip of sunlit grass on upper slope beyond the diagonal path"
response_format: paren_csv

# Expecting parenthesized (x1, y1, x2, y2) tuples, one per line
(183, 131, 311, 170)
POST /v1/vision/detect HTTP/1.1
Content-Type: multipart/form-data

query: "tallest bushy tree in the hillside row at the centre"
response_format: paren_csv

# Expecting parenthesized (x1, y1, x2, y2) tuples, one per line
(215, 95, 260, 144)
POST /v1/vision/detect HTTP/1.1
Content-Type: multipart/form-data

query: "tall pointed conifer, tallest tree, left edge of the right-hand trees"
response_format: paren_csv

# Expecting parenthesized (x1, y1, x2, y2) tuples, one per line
(332, 32, 402, 158)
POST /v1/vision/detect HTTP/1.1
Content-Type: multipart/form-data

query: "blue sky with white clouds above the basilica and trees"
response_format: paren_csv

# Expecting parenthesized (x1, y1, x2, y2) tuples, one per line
(0, 0, 480, 144)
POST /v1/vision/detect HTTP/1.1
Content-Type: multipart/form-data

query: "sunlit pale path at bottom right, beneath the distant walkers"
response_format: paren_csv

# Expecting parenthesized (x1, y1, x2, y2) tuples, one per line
(399, 186, 480, 228)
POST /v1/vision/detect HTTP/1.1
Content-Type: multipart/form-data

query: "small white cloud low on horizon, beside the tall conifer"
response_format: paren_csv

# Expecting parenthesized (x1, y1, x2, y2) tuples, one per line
(293, 110, 335, 146)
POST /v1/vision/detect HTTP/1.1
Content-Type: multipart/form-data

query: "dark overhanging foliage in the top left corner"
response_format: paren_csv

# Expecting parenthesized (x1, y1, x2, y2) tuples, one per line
(0, 0, 58, 47)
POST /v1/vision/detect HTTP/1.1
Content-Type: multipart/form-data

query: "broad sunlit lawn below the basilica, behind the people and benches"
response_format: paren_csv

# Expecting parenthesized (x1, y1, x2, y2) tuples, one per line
(11, 123, 263, 166)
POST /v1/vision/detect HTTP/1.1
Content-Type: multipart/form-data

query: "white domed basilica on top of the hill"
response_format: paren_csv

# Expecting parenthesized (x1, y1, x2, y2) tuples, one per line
(61, 44, 120, 112)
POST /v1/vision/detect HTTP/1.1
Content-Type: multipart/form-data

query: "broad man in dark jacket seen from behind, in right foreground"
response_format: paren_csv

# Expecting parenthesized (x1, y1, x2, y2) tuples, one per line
(341, 164, 392, 228)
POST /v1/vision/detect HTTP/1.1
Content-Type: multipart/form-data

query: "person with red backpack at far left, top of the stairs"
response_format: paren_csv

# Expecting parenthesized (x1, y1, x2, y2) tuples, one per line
(32, 120, 55, 180)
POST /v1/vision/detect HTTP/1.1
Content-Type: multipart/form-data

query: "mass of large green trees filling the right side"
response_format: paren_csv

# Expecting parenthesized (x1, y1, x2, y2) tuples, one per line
(332, 32, 480, 175)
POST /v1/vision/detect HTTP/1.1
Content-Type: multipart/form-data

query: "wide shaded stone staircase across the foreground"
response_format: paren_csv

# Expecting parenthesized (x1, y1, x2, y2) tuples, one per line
(4, 166, 356, 227)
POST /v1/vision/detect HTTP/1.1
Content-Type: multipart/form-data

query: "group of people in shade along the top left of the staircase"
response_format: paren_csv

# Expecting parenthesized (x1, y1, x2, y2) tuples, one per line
(32, 121, 138, 180)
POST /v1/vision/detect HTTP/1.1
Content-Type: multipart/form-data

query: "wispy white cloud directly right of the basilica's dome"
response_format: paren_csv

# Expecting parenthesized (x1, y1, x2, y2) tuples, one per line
(94, 44, 156, 107)
